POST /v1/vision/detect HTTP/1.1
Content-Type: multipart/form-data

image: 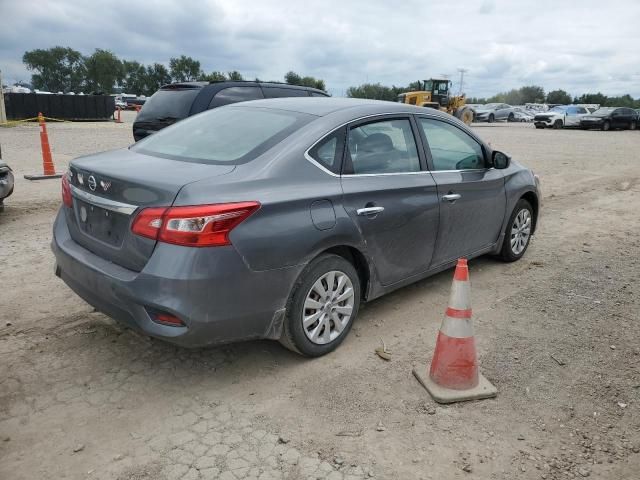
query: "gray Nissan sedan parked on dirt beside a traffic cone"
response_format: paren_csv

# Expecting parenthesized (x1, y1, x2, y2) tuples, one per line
(52, 98, 540, 356)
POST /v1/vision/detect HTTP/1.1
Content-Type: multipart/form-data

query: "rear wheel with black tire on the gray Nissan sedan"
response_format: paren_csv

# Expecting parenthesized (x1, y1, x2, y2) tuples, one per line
(280, 254, 360, 357)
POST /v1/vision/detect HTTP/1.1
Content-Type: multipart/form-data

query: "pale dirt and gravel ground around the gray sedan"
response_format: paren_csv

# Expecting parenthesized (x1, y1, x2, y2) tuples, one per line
(0, 114, 640, 480)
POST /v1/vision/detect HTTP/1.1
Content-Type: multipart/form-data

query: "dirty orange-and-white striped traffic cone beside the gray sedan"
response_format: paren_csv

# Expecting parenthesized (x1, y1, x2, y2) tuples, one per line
(413, 258, 498, 403)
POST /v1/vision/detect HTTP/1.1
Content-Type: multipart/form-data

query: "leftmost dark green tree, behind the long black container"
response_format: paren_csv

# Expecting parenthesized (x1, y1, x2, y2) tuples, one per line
(22, 46, 86, 92)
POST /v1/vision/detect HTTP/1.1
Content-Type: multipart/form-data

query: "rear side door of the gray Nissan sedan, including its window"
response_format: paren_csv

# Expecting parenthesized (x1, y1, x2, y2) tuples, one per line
(341, 115, 439, 285)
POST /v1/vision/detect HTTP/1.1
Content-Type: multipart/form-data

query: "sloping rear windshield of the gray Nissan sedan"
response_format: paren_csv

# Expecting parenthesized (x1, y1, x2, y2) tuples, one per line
(130, 106, 315, 164)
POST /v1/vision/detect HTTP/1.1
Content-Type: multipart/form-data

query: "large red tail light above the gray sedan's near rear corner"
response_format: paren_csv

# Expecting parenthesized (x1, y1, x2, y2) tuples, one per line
(131, 202, 260, 247)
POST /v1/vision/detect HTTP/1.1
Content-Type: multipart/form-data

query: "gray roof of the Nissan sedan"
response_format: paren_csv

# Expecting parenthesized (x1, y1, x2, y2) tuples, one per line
(230, 97, 448, 117)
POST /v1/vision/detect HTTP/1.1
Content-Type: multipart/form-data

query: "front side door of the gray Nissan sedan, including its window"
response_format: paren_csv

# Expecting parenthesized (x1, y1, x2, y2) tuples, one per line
(417, 116, 506, 266)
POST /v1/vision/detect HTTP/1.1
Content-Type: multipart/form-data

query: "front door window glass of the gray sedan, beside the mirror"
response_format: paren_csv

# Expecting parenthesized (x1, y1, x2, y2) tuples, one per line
(418, 118, 485, 170)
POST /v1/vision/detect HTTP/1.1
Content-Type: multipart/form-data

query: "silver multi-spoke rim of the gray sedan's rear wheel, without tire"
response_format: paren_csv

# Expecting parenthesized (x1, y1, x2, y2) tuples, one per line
(302, 270, 355, 345)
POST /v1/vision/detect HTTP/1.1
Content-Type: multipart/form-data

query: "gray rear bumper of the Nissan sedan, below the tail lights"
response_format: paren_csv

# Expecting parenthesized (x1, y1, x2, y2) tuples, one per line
(51, 207, 302, 347)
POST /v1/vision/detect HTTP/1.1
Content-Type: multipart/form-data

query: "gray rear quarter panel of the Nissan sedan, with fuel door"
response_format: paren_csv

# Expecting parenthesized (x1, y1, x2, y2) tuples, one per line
(175, 151, 364, 271)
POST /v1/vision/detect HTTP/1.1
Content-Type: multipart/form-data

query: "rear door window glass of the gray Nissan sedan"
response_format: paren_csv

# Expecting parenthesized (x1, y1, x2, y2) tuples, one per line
(344, 119, 420, 175)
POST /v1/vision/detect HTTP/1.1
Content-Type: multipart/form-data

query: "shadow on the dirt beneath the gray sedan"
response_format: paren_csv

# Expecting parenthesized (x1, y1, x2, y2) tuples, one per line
(50, 257, 504, 390)
